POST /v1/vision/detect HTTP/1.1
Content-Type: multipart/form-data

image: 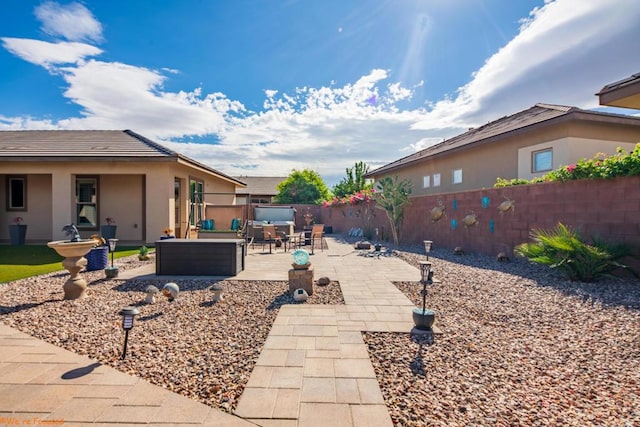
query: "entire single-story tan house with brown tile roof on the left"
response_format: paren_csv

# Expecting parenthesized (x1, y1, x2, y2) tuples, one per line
(0, 130, 244, 244)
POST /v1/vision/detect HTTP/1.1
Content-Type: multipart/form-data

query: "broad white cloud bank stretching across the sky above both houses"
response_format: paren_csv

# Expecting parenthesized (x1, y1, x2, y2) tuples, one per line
(0, 0, 640, 183)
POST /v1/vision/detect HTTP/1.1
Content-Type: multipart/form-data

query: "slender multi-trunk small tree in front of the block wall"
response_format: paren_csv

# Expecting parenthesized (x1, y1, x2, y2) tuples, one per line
(374, 175, 412, 245)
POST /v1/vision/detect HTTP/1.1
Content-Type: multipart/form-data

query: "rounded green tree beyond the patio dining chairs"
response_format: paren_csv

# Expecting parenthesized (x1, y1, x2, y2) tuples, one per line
(275, 169, 329, 204)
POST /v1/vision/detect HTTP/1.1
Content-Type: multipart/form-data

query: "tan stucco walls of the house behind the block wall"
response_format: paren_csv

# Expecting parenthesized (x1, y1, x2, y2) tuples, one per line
(370, 111, 640, 196)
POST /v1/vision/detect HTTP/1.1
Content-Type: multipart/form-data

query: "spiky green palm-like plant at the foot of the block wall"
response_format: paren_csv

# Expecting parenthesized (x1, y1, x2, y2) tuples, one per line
(514, 223, 637, 282)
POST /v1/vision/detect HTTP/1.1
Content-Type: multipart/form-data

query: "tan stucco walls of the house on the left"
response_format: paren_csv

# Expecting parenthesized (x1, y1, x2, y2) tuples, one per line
(0, 160, 242, 244)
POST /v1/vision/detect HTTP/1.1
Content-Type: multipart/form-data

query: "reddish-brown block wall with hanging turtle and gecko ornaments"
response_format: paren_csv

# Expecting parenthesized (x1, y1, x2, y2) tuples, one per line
(296, 176, 640, 256)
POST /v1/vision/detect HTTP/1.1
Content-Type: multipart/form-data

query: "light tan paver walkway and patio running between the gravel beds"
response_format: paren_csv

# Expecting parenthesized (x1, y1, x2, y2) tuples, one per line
(0, 237, 430, 427)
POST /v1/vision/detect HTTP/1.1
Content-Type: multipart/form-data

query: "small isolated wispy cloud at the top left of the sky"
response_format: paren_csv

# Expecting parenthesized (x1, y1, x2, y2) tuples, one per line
(34, 1, 102, 42)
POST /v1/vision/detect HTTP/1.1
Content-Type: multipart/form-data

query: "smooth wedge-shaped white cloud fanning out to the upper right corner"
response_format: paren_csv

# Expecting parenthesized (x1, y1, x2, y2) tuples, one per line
(414, 0, 640, 130)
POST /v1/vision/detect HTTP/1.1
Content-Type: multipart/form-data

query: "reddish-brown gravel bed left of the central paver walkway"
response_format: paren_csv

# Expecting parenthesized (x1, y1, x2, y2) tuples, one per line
(0, 252, 344, 412)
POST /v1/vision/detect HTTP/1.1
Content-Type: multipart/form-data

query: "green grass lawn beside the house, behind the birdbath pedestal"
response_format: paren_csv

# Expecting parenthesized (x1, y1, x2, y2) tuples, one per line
(0, 245, 145, 283)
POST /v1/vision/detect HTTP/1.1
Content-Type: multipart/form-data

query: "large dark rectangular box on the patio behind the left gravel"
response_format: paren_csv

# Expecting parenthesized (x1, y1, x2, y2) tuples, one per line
(155, 239, 245, 276)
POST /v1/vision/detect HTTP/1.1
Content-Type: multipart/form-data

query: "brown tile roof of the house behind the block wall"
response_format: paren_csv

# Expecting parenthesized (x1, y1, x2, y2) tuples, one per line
(366, 103, 640, 177)
